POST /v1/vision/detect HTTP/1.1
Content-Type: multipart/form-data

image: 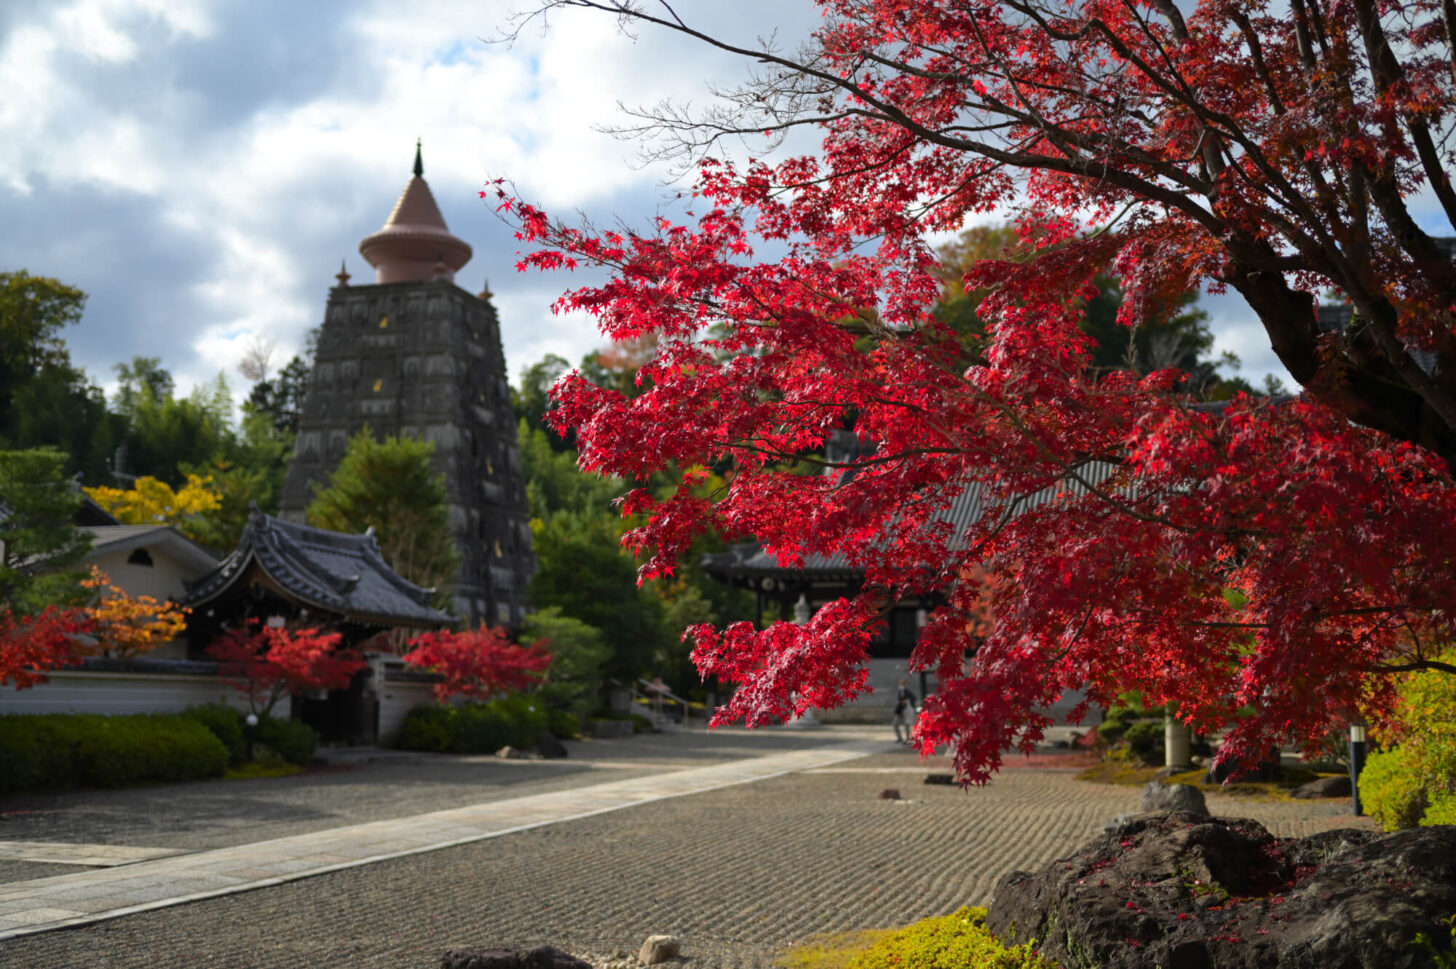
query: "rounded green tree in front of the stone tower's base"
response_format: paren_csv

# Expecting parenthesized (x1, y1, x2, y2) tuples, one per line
(306, 426, 460, 588)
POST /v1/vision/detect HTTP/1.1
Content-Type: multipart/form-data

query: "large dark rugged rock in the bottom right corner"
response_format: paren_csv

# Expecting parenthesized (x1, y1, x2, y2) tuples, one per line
(986, 813, 1456, 969)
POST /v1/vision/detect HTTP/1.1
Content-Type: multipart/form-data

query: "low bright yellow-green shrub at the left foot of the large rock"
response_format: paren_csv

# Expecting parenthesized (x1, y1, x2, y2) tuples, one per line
(849, 908, 1057, 969)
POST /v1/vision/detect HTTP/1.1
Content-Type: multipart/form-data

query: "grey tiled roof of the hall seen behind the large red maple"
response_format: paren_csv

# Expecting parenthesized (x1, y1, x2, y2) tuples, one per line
(702, 461, 1118, 581)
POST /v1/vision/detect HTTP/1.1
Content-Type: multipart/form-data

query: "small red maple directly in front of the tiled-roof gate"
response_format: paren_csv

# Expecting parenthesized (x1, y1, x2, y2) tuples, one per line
(207, 620, 368, 716)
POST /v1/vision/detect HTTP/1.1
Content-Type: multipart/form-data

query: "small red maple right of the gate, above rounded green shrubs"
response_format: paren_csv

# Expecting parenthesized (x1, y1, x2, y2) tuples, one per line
(405, 624, 552, 701)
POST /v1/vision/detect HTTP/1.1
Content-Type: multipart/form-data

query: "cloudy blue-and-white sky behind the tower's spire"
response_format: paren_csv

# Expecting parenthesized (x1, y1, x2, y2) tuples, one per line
(0, 0, 1298, 390)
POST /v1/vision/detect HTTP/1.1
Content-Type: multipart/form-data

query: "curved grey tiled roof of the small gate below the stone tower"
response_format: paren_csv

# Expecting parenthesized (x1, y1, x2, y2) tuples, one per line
(183, 508, 454, 627)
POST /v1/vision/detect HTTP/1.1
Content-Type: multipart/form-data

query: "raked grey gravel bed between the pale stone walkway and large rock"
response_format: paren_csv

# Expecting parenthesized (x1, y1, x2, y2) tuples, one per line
(0, 730, 1348, 969)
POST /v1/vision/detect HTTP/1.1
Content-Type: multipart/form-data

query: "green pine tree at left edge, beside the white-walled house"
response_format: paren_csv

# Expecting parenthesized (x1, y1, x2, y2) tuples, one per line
(0, 448, 92, 615)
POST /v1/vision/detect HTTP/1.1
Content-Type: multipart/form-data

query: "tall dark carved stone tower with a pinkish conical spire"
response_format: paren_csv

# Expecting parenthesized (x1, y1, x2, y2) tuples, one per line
(281, 147, 534, 627)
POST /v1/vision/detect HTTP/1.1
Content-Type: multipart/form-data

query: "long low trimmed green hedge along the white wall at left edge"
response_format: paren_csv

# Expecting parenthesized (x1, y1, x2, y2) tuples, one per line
(0, 713, 227, 791)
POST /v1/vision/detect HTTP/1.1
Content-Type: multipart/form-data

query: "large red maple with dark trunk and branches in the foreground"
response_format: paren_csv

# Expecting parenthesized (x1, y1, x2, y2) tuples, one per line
(499, 0, 1456, 780)
